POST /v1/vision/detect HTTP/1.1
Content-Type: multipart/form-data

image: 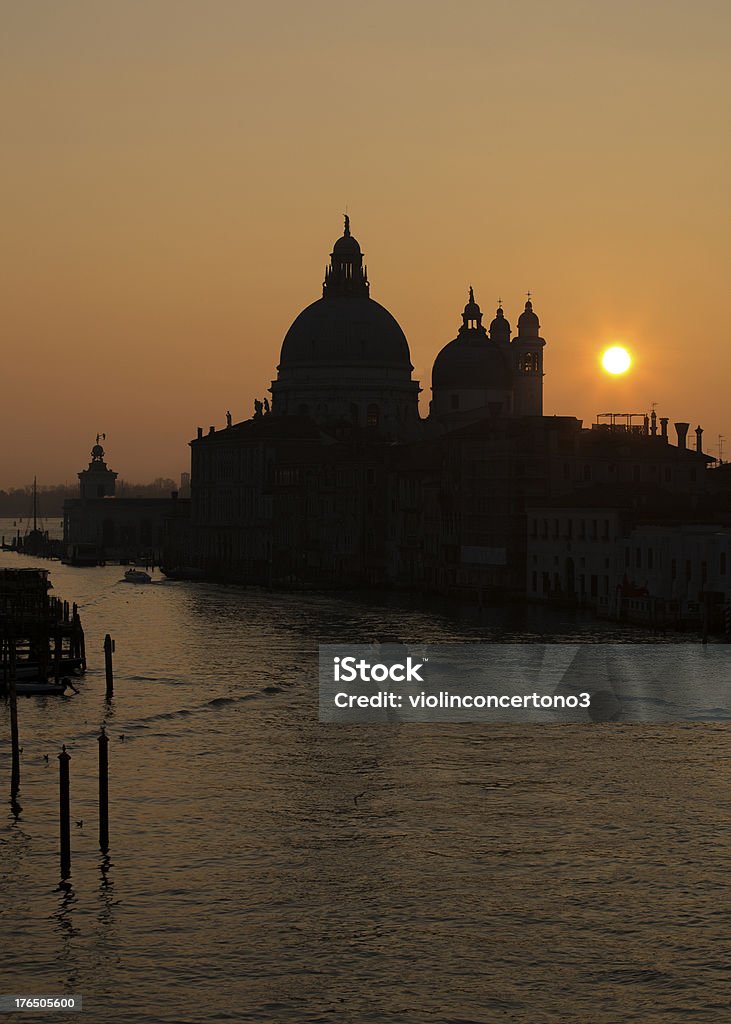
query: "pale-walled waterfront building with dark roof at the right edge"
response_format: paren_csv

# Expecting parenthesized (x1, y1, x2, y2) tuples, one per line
(525, 453, 731, 626)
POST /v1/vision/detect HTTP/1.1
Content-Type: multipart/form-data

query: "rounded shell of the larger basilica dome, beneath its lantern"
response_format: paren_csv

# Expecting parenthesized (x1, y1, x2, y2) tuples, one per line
(278, 295, 414, 374)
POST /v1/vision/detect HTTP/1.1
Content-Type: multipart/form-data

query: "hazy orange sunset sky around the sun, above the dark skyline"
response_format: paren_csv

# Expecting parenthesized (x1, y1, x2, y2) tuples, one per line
(0, 0, 731, 486)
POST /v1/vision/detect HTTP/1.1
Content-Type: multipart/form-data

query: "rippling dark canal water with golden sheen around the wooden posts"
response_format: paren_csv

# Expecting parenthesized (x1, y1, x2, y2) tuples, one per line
(0, 552, 731, 1024)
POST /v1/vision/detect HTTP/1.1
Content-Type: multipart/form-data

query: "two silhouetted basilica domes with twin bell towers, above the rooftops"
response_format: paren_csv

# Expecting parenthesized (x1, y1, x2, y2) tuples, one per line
(271, 216, 545, 440)
